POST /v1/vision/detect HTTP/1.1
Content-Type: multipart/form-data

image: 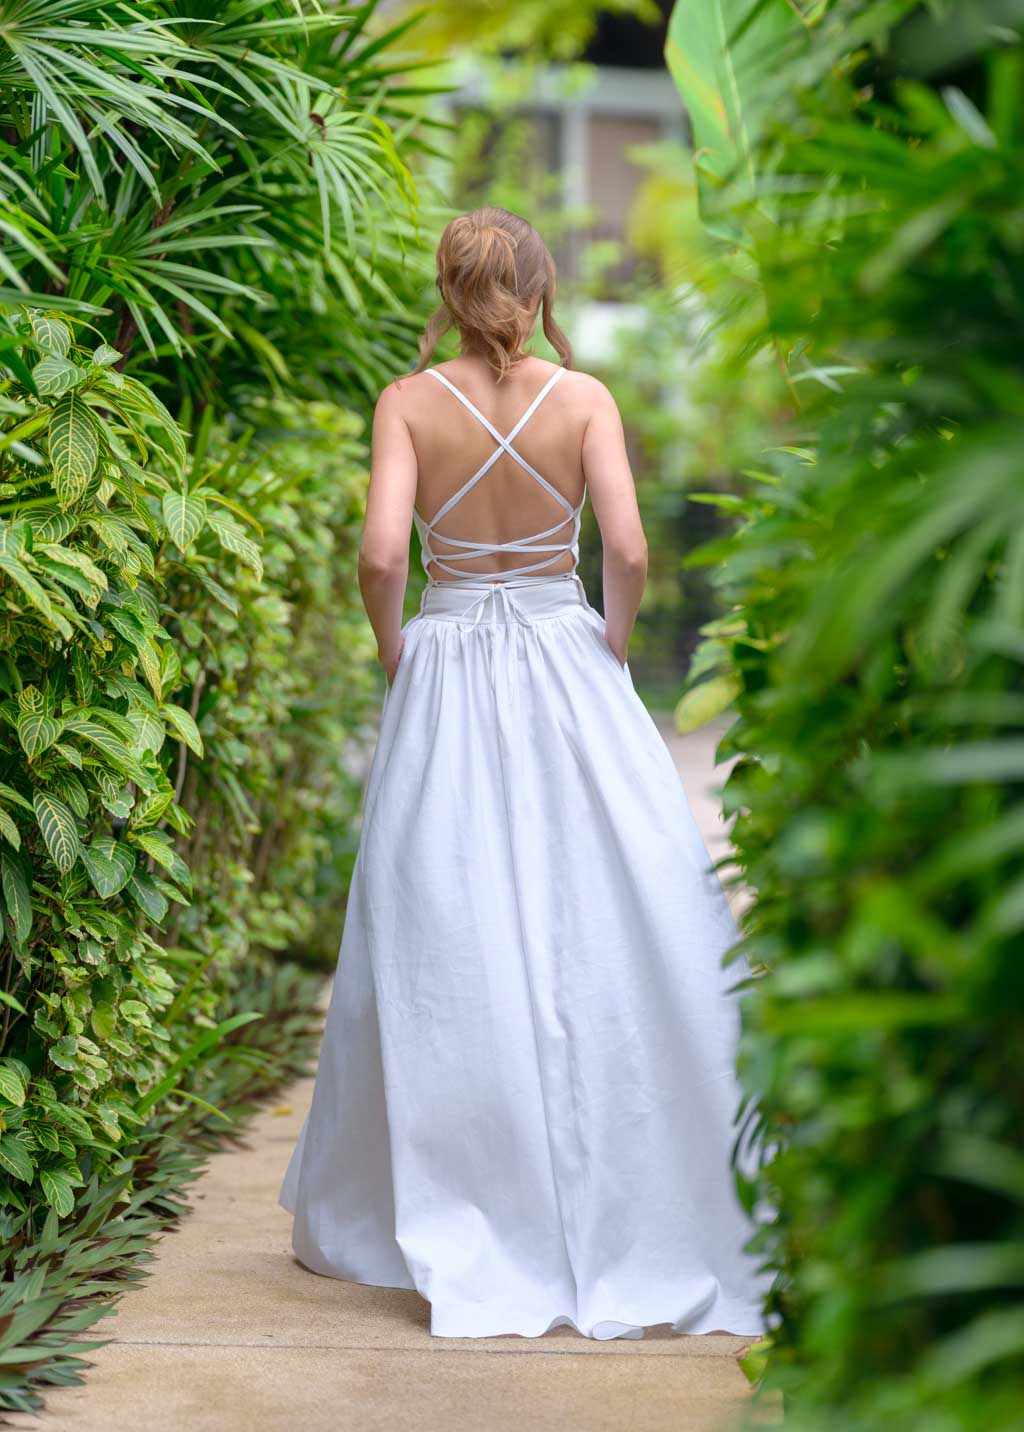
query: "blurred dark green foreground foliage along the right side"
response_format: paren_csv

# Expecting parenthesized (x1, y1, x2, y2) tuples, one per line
(670, 0, 1024, 1432)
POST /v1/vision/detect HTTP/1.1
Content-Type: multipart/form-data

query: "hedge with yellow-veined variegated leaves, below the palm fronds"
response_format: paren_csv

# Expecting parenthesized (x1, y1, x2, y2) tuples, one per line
(0, 311, 378, 1403)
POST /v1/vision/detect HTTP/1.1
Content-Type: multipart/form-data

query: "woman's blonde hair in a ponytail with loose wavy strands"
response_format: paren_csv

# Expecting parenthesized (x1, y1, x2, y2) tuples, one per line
(415, 205, 573, 382)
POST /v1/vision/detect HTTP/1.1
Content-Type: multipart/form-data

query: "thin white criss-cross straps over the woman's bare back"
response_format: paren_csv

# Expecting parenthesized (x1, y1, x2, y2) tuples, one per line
(414, 368, 586, 581)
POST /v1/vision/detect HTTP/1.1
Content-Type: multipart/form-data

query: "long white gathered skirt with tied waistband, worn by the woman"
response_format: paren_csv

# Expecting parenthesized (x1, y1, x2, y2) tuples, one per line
(281, 579, 769, 1337)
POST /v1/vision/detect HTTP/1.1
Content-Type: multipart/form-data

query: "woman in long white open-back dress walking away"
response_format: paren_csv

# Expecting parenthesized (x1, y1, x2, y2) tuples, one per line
(281, 208, 766, 1337)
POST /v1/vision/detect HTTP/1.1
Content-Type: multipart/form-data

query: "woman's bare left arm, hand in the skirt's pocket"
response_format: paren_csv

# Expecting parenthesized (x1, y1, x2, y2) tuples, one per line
(359, 384, 417, 682)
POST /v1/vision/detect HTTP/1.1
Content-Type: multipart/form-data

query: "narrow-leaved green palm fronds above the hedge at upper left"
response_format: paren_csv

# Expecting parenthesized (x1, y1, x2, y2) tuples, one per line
(0, 0, 431, 406)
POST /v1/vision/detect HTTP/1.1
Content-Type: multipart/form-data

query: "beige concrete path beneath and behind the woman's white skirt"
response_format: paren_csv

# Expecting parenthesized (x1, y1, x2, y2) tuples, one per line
(11, 723, 778, 1432)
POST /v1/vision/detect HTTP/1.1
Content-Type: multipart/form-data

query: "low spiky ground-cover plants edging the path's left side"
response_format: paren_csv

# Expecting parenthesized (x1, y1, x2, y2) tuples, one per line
(0, 959, 319, 1412)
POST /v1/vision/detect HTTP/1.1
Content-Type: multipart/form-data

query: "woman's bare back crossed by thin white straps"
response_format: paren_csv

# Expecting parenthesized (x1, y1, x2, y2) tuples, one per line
(401, 358, 587, 581)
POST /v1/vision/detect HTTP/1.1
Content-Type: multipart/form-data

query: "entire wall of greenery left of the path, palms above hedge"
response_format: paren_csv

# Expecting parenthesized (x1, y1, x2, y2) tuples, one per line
(0, 0, 430, 1406)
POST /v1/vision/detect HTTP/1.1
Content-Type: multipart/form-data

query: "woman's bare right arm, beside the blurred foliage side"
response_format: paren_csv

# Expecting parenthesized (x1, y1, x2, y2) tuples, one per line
(583, 378, 647, 666)
